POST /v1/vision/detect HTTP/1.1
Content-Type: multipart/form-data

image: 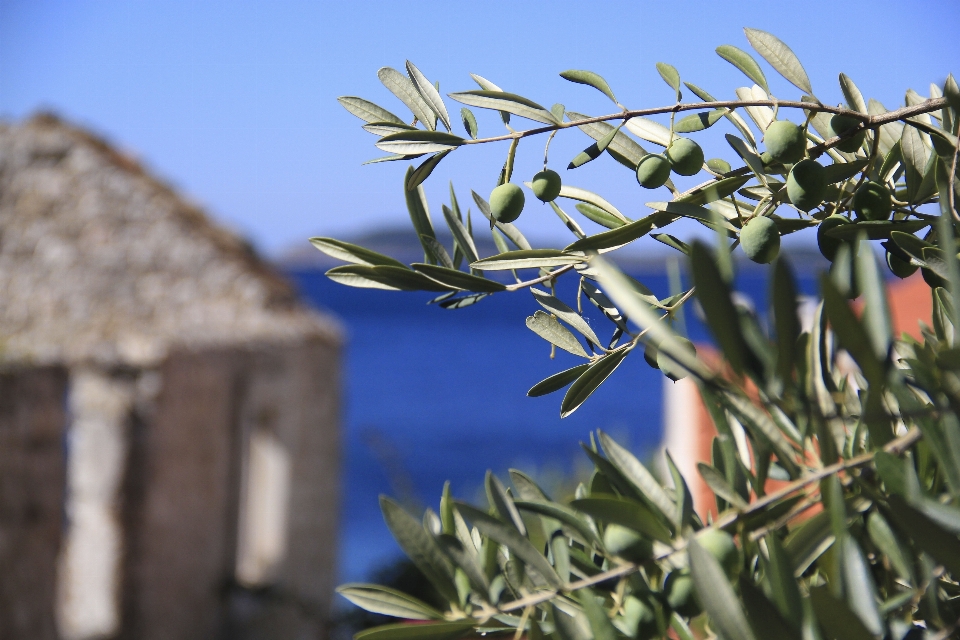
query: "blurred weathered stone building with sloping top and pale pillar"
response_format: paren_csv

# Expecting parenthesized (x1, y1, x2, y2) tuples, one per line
(0, 116, 340, 640)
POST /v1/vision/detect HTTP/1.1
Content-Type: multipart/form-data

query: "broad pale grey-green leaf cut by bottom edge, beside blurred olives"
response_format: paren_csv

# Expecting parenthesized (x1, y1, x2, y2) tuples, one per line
(687, 538, 757, 640)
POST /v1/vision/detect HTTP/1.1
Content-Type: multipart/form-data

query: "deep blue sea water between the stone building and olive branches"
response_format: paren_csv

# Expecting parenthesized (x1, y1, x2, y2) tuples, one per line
(288, 268, 814, 582)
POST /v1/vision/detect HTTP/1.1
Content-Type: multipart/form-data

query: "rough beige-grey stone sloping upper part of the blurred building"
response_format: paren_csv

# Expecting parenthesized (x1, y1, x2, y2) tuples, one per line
(0, 116, 337, 366)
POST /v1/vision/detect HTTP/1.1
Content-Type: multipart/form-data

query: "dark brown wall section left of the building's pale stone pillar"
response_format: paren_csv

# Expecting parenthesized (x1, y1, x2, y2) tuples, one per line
(0, 367, 67, 640)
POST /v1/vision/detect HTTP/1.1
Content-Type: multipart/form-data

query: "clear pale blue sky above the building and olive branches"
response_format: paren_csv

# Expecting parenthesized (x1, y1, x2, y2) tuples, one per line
(0, 0, 960, 253)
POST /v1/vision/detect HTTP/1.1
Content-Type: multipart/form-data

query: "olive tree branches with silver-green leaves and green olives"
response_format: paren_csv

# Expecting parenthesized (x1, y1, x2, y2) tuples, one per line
(313, 29, 960, 640)
